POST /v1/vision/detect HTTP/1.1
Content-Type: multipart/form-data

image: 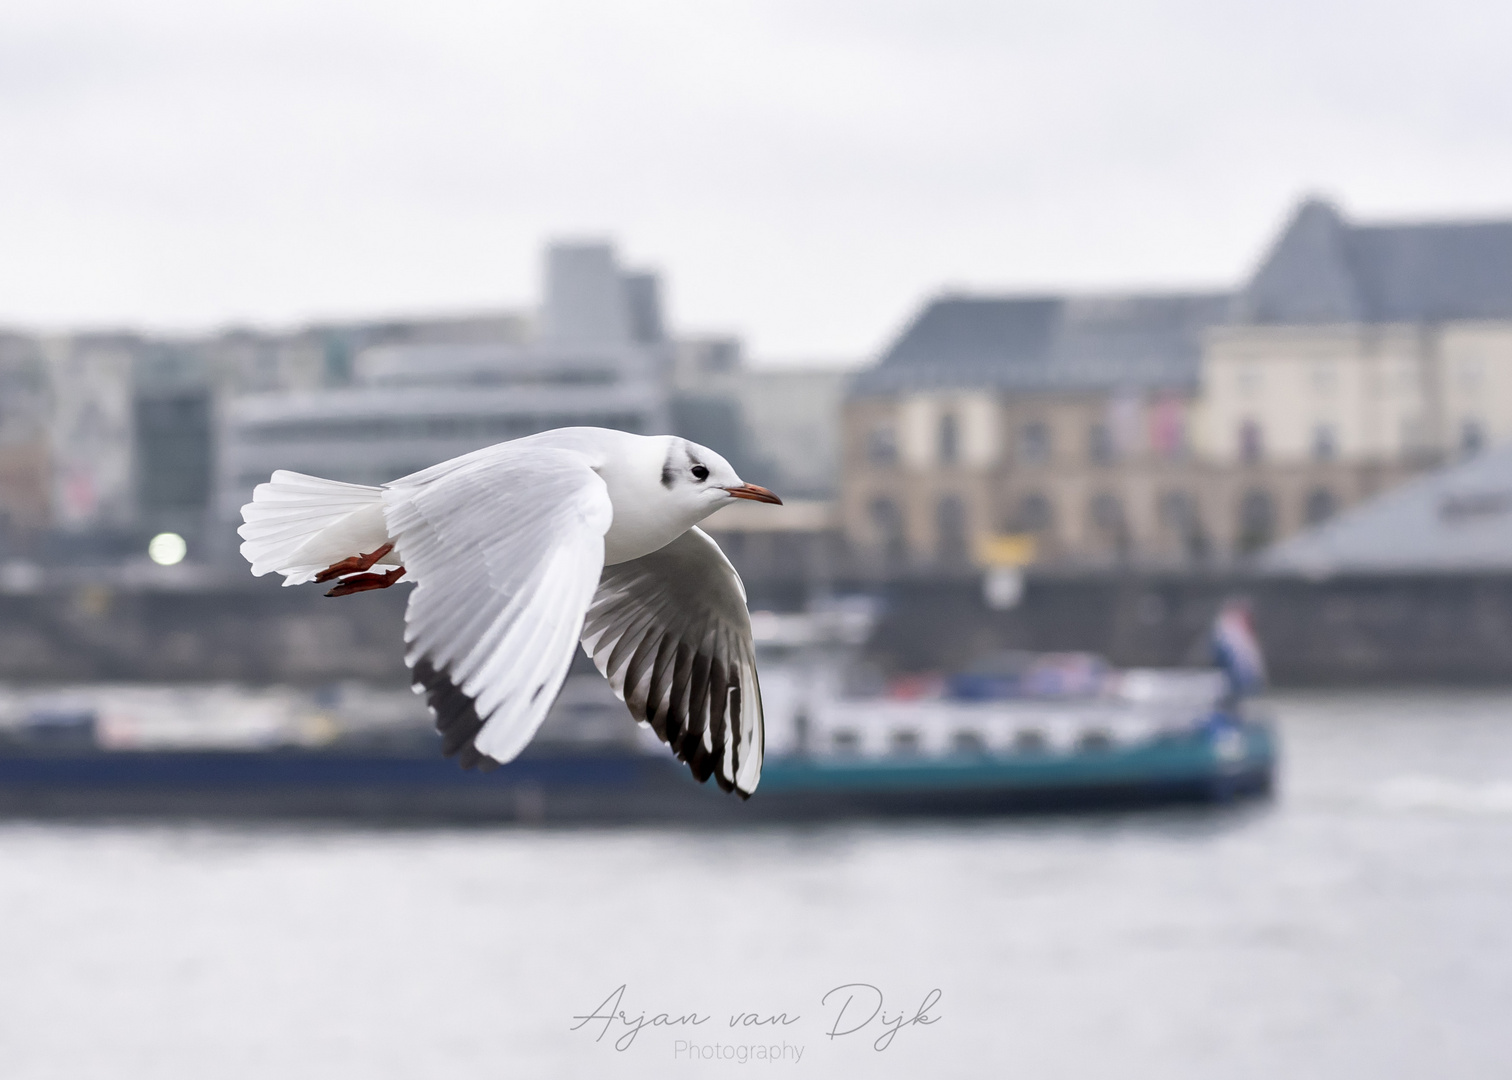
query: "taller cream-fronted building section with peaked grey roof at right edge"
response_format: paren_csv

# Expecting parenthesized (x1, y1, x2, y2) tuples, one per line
(1201, 201, 1512, 548)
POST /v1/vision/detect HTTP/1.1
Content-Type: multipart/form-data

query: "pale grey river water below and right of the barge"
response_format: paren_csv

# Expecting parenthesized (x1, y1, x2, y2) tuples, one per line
(0, 691, 1512, 1080)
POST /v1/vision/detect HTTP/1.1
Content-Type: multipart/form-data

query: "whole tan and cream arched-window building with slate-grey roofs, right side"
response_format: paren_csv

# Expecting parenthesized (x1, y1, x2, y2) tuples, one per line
(842, 201, 1512, 572)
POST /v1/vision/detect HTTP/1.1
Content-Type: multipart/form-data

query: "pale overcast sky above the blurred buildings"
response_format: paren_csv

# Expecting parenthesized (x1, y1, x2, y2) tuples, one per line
(0, 0, 1512, 358)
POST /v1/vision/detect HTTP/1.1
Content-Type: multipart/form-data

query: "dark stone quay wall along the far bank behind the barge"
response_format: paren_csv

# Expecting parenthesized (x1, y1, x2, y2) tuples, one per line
(0, 573, 1512, 685)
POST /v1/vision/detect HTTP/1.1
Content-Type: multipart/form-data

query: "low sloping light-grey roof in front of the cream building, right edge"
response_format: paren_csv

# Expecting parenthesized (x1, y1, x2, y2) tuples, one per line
(1261, 446, 1512, 576)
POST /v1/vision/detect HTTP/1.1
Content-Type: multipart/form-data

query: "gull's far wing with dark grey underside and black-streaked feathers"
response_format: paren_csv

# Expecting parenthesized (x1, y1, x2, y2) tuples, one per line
(582, 529, 764, 797)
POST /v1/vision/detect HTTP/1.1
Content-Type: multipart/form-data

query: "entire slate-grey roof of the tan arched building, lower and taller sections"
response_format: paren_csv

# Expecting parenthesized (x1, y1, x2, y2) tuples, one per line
(853, 200, 1512, 396)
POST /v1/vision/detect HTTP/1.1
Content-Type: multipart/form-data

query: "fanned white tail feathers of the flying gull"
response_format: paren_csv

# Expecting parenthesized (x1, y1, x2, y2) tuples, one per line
(237, 469, 398, 585)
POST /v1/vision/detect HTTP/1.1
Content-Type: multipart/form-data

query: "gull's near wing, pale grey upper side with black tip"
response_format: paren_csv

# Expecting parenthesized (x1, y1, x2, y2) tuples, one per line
(383, 443, 614, 768)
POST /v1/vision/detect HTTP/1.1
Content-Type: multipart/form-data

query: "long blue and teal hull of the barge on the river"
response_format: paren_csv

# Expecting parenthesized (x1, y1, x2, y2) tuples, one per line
(0, 722, 1276, 824)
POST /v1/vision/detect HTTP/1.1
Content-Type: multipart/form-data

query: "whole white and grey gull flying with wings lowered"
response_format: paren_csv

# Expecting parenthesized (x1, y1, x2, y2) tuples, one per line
(237, 428, 782, 797)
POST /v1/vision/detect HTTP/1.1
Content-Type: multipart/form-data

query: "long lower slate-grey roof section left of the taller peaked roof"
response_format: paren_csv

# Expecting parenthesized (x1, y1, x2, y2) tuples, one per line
(853, 293, 1232, 396)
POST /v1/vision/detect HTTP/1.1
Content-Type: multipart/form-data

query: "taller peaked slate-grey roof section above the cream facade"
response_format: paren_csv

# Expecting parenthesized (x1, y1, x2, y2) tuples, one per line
(1238, 200, 1512, 324)
